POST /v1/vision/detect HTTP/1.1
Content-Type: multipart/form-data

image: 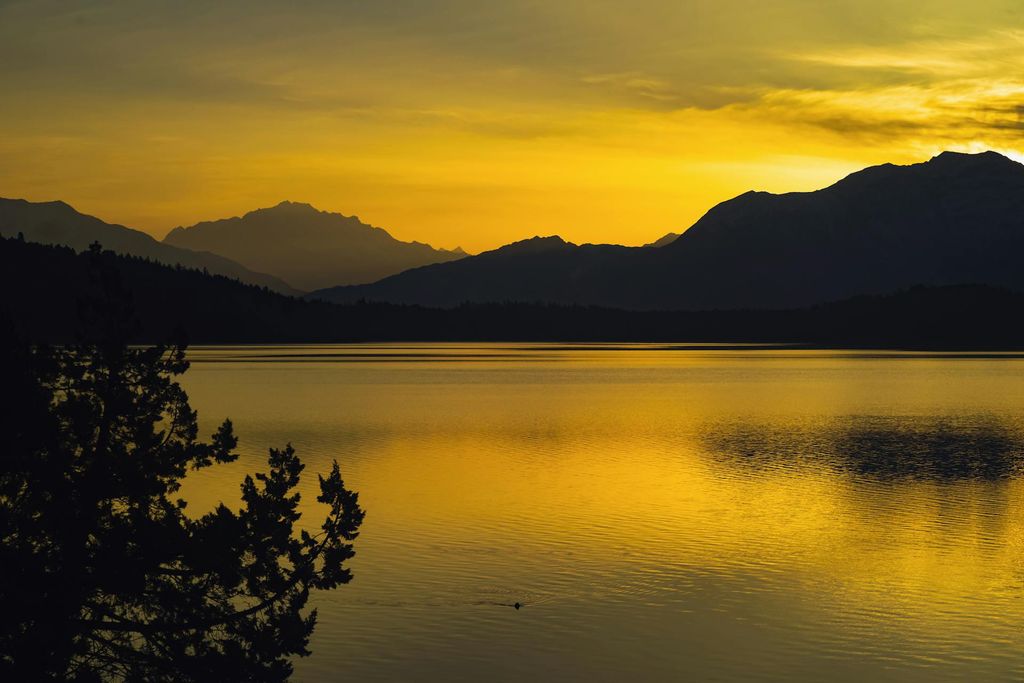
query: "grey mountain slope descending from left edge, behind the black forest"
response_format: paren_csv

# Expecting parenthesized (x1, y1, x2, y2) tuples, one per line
(0, 198, 298, 294)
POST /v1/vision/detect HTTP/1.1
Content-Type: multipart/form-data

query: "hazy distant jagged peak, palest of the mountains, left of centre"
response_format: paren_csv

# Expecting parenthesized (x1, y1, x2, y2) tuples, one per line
(164, 202, 465, 290)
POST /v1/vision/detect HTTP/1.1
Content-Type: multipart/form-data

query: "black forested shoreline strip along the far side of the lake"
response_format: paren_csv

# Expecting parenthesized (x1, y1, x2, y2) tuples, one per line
(6, 239, 1024, 349)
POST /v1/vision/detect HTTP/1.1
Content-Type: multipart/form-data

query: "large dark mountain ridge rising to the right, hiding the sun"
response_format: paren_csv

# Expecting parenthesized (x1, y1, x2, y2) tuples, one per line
(309, 152, 1024, 310)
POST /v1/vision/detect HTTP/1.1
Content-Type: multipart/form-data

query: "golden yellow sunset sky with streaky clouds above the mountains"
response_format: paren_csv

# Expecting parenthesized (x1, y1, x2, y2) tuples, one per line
(0, 0, 1024, 252)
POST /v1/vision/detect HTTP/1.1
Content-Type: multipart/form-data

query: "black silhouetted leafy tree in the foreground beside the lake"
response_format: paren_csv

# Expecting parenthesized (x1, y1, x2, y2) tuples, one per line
(0, 250, 362, 681)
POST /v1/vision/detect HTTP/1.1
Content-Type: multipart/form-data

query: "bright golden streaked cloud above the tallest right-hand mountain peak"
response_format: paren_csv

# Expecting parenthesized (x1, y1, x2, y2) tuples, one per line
(704, 30, 1024, 146)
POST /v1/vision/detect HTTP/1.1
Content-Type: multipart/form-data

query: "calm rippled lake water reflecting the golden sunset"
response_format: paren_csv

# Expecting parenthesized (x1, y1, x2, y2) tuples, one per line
(183, 344, 1024, 681)
